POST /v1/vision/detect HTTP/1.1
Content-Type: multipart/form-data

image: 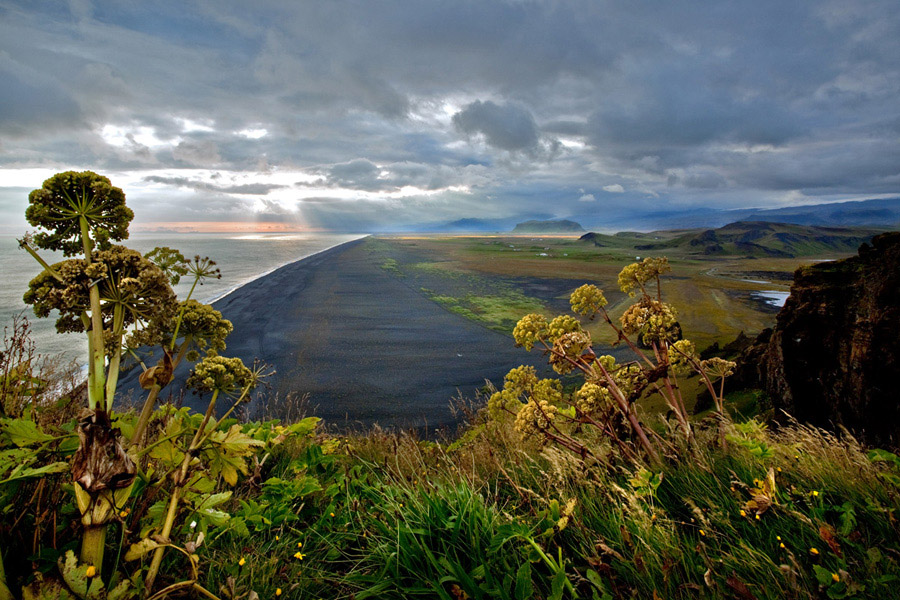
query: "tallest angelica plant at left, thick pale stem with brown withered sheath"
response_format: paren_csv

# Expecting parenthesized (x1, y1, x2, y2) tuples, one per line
(19, 171, 175, 570)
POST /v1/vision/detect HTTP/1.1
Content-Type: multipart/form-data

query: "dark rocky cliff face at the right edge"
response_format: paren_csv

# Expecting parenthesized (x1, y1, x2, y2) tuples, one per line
(743, 232, 900, 445)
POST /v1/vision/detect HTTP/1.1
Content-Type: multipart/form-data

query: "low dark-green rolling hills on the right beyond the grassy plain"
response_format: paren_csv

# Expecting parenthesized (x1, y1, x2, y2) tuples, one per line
(581, 221, 882, 258)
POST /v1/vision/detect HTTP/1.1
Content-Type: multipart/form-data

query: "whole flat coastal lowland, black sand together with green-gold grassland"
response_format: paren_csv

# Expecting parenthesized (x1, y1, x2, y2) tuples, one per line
(120, 227, 872, 433)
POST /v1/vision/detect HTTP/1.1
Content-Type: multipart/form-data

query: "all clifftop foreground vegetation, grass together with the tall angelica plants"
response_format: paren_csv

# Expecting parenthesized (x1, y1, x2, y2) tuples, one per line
(0, 172, 900, 600)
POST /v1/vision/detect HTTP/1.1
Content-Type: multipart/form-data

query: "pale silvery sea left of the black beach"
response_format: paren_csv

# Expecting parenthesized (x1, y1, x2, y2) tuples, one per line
(0, 233, 363, 364)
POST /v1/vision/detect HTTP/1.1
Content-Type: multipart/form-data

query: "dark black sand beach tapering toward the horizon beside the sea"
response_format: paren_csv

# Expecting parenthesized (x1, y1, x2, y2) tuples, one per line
(120, 240, 549, 430)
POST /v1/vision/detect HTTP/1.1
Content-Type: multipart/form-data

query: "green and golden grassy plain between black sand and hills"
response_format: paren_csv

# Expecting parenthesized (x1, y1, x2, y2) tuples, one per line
(367, 231, 880, 416)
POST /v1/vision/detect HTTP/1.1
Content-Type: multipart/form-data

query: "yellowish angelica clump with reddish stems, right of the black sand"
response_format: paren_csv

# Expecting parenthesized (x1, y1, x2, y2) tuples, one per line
(500, 258, 734, 462)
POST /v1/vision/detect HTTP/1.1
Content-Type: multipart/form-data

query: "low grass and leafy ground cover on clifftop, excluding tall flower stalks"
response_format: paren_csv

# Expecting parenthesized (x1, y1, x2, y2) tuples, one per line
(0, 338, 900, 600)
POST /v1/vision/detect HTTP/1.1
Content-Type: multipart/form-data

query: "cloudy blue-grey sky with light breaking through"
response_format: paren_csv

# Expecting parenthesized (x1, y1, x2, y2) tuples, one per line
(0, 0, 900, 233)
